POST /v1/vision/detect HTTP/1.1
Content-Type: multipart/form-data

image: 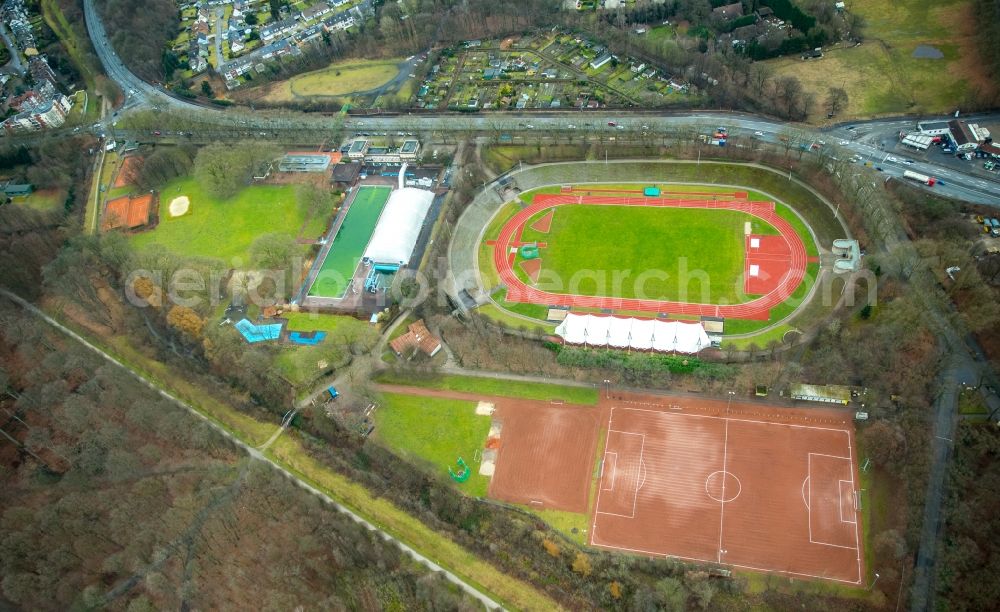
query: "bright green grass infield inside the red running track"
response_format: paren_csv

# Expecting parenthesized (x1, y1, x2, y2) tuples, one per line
(515, 205, 778, 304)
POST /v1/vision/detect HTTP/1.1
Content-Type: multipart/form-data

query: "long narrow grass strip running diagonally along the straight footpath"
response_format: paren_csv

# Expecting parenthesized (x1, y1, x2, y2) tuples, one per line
(43, 304, 558, 610)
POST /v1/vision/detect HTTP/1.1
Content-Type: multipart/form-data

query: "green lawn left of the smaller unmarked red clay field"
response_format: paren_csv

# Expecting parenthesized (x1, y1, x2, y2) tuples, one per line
(375, 393, 490, 497)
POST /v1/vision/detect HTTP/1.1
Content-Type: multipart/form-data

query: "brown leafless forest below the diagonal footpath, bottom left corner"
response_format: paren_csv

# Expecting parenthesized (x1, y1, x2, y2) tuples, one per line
(0, 300, 481, 610)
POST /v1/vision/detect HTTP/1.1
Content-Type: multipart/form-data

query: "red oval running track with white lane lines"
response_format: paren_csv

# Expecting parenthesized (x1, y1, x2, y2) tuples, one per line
(493, 194, 807, 320)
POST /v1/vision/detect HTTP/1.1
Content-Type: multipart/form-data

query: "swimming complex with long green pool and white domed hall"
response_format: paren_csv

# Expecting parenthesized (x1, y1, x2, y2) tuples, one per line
(296, 167, 435, 311)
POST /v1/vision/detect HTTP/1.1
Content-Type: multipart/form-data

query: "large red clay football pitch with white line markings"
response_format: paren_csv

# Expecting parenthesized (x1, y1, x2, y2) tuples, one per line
(590, 398, 863, 584)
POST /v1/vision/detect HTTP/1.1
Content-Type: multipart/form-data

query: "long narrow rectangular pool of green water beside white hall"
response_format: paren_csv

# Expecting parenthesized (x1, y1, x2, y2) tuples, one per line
(309, 187, 392, 297)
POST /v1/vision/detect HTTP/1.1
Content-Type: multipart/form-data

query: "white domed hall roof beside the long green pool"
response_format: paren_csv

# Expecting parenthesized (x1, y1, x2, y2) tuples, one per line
(365, 187, 434, 266)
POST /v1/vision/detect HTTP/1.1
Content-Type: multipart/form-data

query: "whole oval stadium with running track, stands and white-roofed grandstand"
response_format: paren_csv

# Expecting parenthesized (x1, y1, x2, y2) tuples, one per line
(451, 162, 859, 353)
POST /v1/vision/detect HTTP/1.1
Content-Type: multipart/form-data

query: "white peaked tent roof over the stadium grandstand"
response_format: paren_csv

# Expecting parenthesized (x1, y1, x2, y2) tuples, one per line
(556, 313, 712, 353)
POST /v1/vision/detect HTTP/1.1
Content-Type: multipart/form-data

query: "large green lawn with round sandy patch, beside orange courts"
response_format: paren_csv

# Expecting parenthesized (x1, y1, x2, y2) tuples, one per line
(132, 178, 305, 265)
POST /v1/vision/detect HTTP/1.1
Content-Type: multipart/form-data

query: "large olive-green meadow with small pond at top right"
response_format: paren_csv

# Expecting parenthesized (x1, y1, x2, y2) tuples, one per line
(767, 0, 980, 121)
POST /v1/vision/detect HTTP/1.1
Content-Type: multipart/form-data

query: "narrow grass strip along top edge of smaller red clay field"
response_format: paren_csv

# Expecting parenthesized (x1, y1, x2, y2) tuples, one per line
(376, 372, 599, 406)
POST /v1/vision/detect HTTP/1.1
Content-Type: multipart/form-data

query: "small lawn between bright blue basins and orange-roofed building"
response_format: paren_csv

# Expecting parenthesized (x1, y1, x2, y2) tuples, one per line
(274, 312, 378, 386)
